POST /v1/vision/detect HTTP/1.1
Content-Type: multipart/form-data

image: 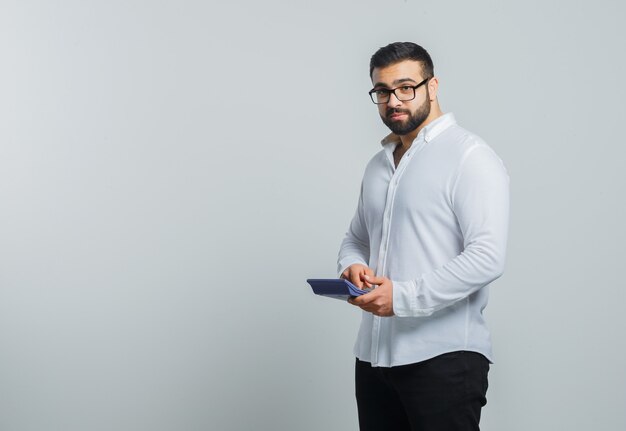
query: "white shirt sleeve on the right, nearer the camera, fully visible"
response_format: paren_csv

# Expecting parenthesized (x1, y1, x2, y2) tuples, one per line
(393, 144, 509, 317)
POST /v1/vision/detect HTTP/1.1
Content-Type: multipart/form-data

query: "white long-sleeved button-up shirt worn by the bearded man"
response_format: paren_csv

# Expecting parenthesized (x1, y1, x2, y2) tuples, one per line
(338, 113, 509, 367)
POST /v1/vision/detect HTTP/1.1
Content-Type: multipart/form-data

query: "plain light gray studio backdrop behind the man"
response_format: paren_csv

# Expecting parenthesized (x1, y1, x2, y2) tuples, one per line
(0, 0, 626, 431)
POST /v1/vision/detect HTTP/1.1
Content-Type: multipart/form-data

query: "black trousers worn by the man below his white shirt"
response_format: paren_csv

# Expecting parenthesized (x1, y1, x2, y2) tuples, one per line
(355, 351, 489, 431)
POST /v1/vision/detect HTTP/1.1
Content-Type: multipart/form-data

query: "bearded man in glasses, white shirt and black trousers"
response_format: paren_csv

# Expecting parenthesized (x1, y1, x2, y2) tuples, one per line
(338, 43, 509, 431)
